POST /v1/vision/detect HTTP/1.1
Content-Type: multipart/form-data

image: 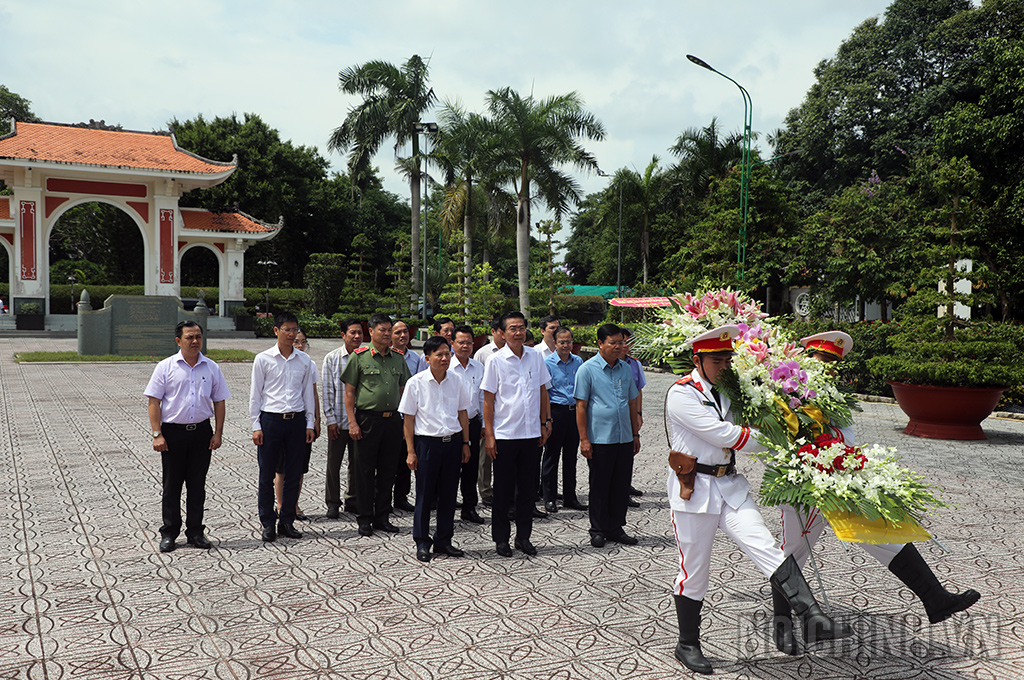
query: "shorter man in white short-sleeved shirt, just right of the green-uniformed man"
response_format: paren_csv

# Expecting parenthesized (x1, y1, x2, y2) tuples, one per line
(398, 335, 469, 562)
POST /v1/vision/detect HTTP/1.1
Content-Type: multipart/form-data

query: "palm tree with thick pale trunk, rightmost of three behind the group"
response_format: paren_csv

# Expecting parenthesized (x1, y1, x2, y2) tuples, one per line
(487, 87, 604, 313)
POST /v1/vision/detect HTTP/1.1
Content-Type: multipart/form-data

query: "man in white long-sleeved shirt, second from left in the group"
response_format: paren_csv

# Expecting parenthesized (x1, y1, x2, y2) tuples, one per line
(249, 311, 316, 543)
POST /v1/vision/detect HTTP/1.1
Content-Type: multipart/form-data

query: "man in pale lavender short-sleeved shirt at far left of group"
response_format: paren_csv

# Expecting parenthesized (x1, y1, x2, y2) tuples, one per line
(143, 322, 231, 552)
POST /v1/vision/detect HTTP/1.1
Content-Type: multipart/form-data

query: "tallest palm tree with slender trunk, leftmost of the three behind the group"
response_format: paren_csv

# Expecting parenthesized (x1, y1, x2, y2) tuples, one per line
(327, 54, 437, 307)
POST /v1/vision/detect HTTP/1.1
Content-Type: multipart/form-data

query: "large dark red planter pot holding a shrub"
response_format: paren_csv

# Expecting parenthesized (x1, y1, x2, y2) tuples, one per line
(887, 380, 1006, 439)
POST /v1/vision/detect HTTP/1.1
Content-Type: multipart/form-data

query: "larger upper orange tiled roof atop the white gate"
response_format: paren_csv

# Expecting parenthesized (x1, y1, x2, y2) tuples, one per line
(0, 123, 237, 174)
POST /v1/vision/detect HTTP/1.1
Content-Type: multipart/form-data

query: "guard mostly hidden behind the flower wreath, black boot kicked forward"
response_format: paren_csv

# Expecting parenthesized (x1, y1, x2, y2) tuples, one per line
(774, 331, 981, 651)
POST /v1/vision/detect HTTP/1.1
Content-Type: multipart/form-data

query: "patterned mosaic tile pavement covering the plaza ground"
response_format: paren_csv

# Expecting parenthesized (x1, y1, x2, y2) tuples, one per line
(0, 336, 1024, 680)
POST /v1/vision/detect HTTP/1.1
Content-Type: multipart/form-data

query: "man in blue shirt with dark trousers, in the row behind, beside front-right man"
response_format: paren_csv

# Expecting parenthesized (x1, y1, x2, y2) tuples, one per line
(541, 326, 587, 512)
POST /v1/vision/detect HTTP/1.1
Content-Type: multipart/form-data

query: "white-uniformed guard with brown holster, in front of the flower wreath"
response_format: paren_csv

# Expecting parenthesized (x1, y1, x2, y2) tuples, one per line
(665, 326, 853, 674)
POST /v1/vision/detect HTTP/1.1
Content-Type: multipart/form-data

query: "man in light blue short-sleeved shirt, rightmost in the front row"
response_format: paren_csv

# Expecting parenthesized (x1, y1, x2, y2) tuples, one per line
(573, 324, 640, 548)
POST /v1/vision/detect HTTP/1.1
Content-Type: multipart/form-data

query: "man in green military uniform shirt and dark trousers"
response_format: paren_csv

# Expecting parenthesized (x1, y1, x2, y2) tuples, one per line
(341, 314, 411, 536)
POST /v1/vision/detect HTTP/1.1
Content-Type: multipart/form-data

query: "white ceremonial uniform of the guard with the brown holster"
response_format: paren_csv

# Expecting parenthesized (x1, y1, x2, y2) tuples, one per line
(665, 370, 784, 600)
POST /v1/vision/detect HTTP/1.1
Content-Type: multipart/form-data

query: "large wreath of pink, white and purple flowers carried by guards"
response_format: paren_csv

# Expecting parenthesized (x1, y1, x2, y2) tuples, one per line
(634, 290, 942, 523)
